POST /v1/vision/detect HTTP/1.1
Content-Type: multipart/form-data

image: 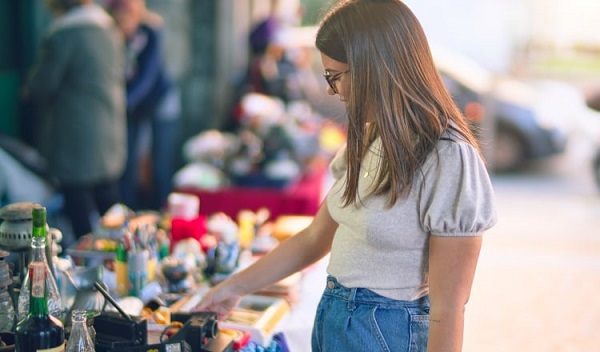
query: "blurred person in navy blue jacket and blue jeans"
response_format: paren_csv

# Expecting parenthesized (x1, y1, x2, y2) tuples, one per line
(104, 0, 181, 209)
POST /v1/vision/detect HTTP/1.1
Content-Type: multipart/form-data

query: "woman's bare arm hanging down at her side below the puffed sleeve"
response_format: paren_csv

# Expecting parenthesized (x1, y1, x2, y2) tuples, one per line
(427, 235, 482, 352)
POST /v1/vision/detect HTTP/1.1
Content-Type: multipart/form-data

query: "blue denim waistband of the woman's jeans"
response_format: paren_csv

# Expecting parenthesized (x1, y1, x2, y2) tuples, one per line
(324, 276, 429, 308)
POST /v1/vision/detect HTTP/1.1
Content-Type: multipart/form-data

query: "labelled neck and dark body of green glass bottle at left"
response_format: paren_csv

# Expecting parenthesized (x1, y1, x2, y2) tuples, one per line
(15, 262, 65, 352)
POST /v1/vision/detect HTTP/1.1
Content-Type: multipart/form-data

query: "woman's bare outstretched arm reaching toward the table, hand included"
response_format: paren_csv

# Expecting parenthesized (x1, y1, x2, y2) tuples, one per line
(194, 202, 337, 320)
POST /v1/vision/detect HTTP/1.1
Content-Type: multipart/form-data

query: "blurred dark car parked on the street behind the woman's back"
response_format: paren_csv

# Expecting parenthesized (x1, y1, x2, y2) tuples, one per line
(432, 47, 572, 172)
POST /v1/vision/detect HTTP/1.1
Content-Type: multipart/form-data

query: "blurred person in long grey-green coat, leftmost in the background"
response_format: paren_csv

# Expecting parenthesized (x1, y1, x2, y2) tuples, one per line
(23, 0, 126, 238)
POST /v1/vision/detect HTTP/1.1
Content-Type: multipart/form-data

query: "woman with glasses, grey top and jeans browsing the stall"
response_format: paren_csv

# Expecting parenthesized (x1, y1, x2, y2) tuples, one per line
(195, 0, 496, 352)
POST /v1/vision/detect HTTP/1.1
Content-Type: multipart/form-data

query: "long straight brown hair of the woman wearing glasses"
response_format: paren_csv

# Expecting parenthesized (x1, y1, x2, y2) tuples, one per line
(316, 0, 479, 206)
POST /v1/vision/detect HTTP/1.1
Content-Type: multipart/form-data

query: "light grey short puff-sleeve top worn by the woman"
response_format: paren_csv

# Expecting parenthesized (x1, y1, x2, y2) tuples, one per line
(327, 132, 496, 300)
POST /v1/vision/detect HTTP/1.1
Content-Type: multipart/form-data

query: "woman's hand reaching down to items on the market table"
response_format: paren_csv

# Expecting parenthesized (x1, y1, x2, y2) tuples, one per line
(191, 281, 242, 321)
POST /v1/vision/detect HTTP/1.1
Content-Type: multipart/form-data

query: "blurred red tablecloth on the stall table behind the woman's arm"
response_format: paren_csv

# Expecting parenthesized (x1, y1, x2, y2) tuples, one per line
(176, 166, 326, 219)
